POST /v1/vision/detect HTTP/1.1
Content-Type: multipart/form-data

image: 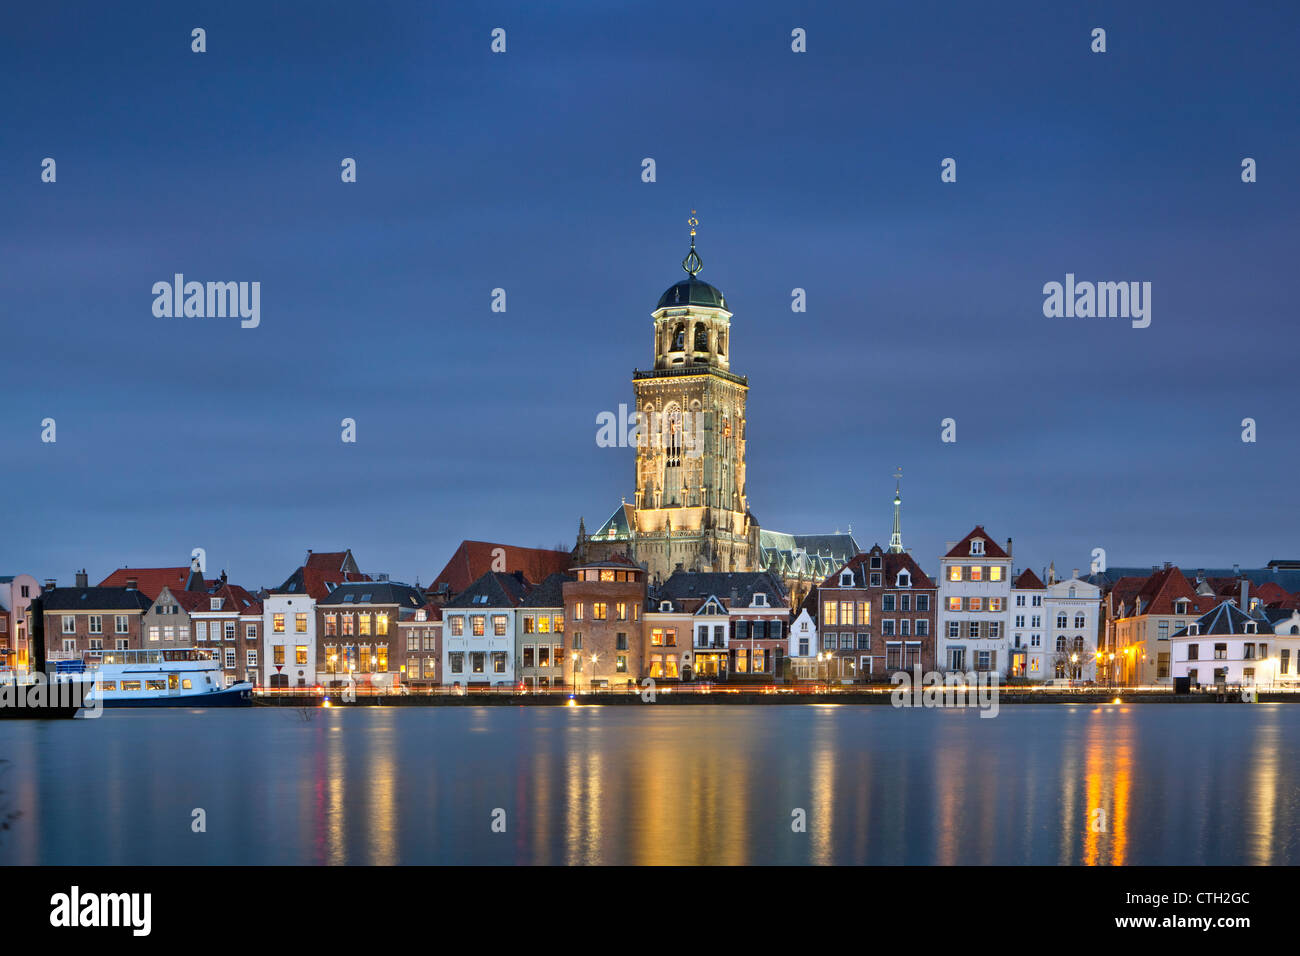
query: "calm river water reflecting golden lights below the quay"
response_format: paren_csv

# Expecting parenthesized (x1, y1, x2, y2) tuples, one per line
(0, 704, 1300, 865)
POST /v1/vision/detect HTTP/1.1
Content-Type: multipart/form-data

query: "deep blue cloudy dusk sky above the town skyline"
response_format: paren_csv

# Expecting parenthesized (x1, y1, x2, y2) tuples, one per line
(0, 0, 1300, 587)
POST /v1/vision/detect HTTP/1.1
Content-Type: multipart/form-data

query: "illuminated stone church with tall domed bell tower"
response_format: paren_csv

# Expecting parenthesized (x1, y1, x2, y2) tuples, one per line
(576, 217, 858, 605)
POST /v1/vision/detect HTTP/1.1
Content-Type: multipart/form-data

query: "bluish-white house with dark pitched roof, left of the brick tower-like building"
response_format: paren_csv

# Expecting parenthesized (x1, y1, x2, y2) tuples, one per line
(442, 571, 529, 687)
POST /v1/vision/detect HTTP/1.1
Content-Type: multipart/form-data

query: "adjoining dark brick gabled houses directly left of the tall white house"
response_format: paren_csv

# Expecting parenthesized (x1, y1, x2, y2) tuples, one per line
(810, 545, 937, 682)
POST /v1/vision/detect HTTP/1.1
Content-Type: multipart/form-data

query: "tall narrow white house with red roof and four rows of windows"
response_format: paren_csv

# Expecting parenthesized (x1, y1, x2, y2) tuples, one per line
(935, 525, 1011, 675)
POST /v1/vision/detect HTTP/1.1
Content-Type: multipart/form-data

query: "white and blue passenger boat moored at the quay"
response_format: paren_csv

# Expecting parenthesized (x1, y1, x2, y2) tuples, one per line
(52, 648, 252, 708)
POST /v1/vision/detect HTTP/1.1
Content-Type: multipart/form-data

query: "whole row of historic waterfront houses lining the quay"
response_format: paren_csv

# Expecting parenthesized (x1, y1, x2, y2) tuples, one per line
(0, 525, 1300, 688)
